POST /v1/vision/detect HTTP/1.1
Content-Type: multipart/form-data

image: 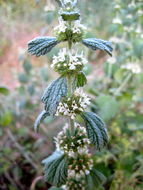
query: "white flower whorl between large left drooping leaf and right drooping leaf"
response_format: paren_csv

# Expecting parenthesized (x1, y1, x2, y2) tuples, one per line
(55, 88, 90, 119)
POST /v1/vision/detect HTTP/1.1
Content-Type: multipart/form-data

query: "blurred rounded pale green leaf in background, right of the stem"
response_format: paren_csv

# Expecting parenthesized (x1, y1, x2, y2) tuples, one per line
(96, 95, 119, 121)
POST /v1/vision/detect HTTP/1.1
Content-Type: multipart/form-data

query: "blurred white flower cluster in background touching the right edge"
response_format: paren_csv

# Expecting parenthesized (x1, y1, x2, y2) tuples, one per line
(121, 63, 142, 74)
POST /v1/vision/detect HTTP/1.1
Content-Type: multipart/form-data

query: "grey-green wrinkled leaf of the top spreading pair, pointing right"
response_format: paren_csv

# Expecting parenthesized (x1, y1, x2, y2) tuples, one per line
(82, 38, 113, 56)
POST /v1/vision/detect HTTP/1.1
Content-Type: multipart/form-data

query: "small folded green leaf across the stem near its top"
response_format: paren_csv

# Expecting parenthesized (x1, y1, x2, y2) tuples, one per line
(61, 12, 80, 21)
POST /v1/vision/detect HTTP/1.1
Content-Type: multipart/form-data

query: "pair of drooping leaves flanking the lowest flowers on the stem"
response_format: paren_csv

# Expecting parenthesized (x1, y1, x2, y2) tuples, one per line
(42, 151, 106, 190)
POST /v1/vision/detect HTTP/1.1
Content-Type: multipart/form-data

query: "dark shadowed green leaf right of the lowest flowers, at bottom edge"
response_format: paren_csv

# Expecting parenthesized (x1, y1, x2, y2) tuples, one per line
(86, 169, 106, 190)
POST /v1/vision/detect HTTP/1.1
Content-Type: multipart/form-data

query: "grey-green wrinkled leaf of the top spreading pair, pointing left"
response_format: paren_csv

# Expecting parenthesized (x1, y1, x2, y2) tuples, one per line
(28, 36, 59, 57)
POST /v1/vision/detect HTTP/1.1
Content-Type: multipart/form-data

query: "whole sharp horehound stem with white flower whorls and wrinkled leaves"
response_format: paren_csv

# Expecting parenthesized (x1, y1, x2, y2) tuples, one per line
(28, 0, 112, 190)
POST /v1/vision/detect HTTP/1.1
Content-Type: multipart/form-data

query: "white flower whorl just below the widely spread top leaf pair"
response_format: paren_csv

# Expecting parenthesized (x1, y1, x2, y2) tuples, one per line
(51, 48, 87, 70)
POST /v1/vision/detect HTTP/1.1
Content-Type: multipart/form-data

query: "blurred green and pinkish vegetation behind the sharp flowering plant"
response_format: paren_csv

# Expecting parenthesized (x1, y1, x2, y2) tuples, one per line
(0, 0, 143, 190)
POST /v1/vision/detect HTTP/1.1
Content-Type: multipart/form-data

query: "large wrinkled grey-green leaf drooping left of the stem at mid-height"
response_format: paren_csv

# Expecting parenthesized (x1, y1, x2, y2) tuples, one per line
(42, 77, 67, 115)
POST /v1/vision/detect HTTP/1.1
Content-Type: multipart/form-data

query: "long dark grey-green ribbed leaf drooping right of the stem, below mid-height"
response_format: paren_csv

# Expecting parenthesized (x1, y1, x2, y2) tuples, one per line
(81, 112, 108, 150)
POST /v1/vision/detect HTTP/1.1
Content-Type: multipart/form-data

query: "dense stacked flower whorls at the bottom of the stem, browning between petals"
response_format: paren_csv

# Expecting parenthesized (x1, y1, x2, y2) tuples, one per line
(55, 123, 93, 189)
